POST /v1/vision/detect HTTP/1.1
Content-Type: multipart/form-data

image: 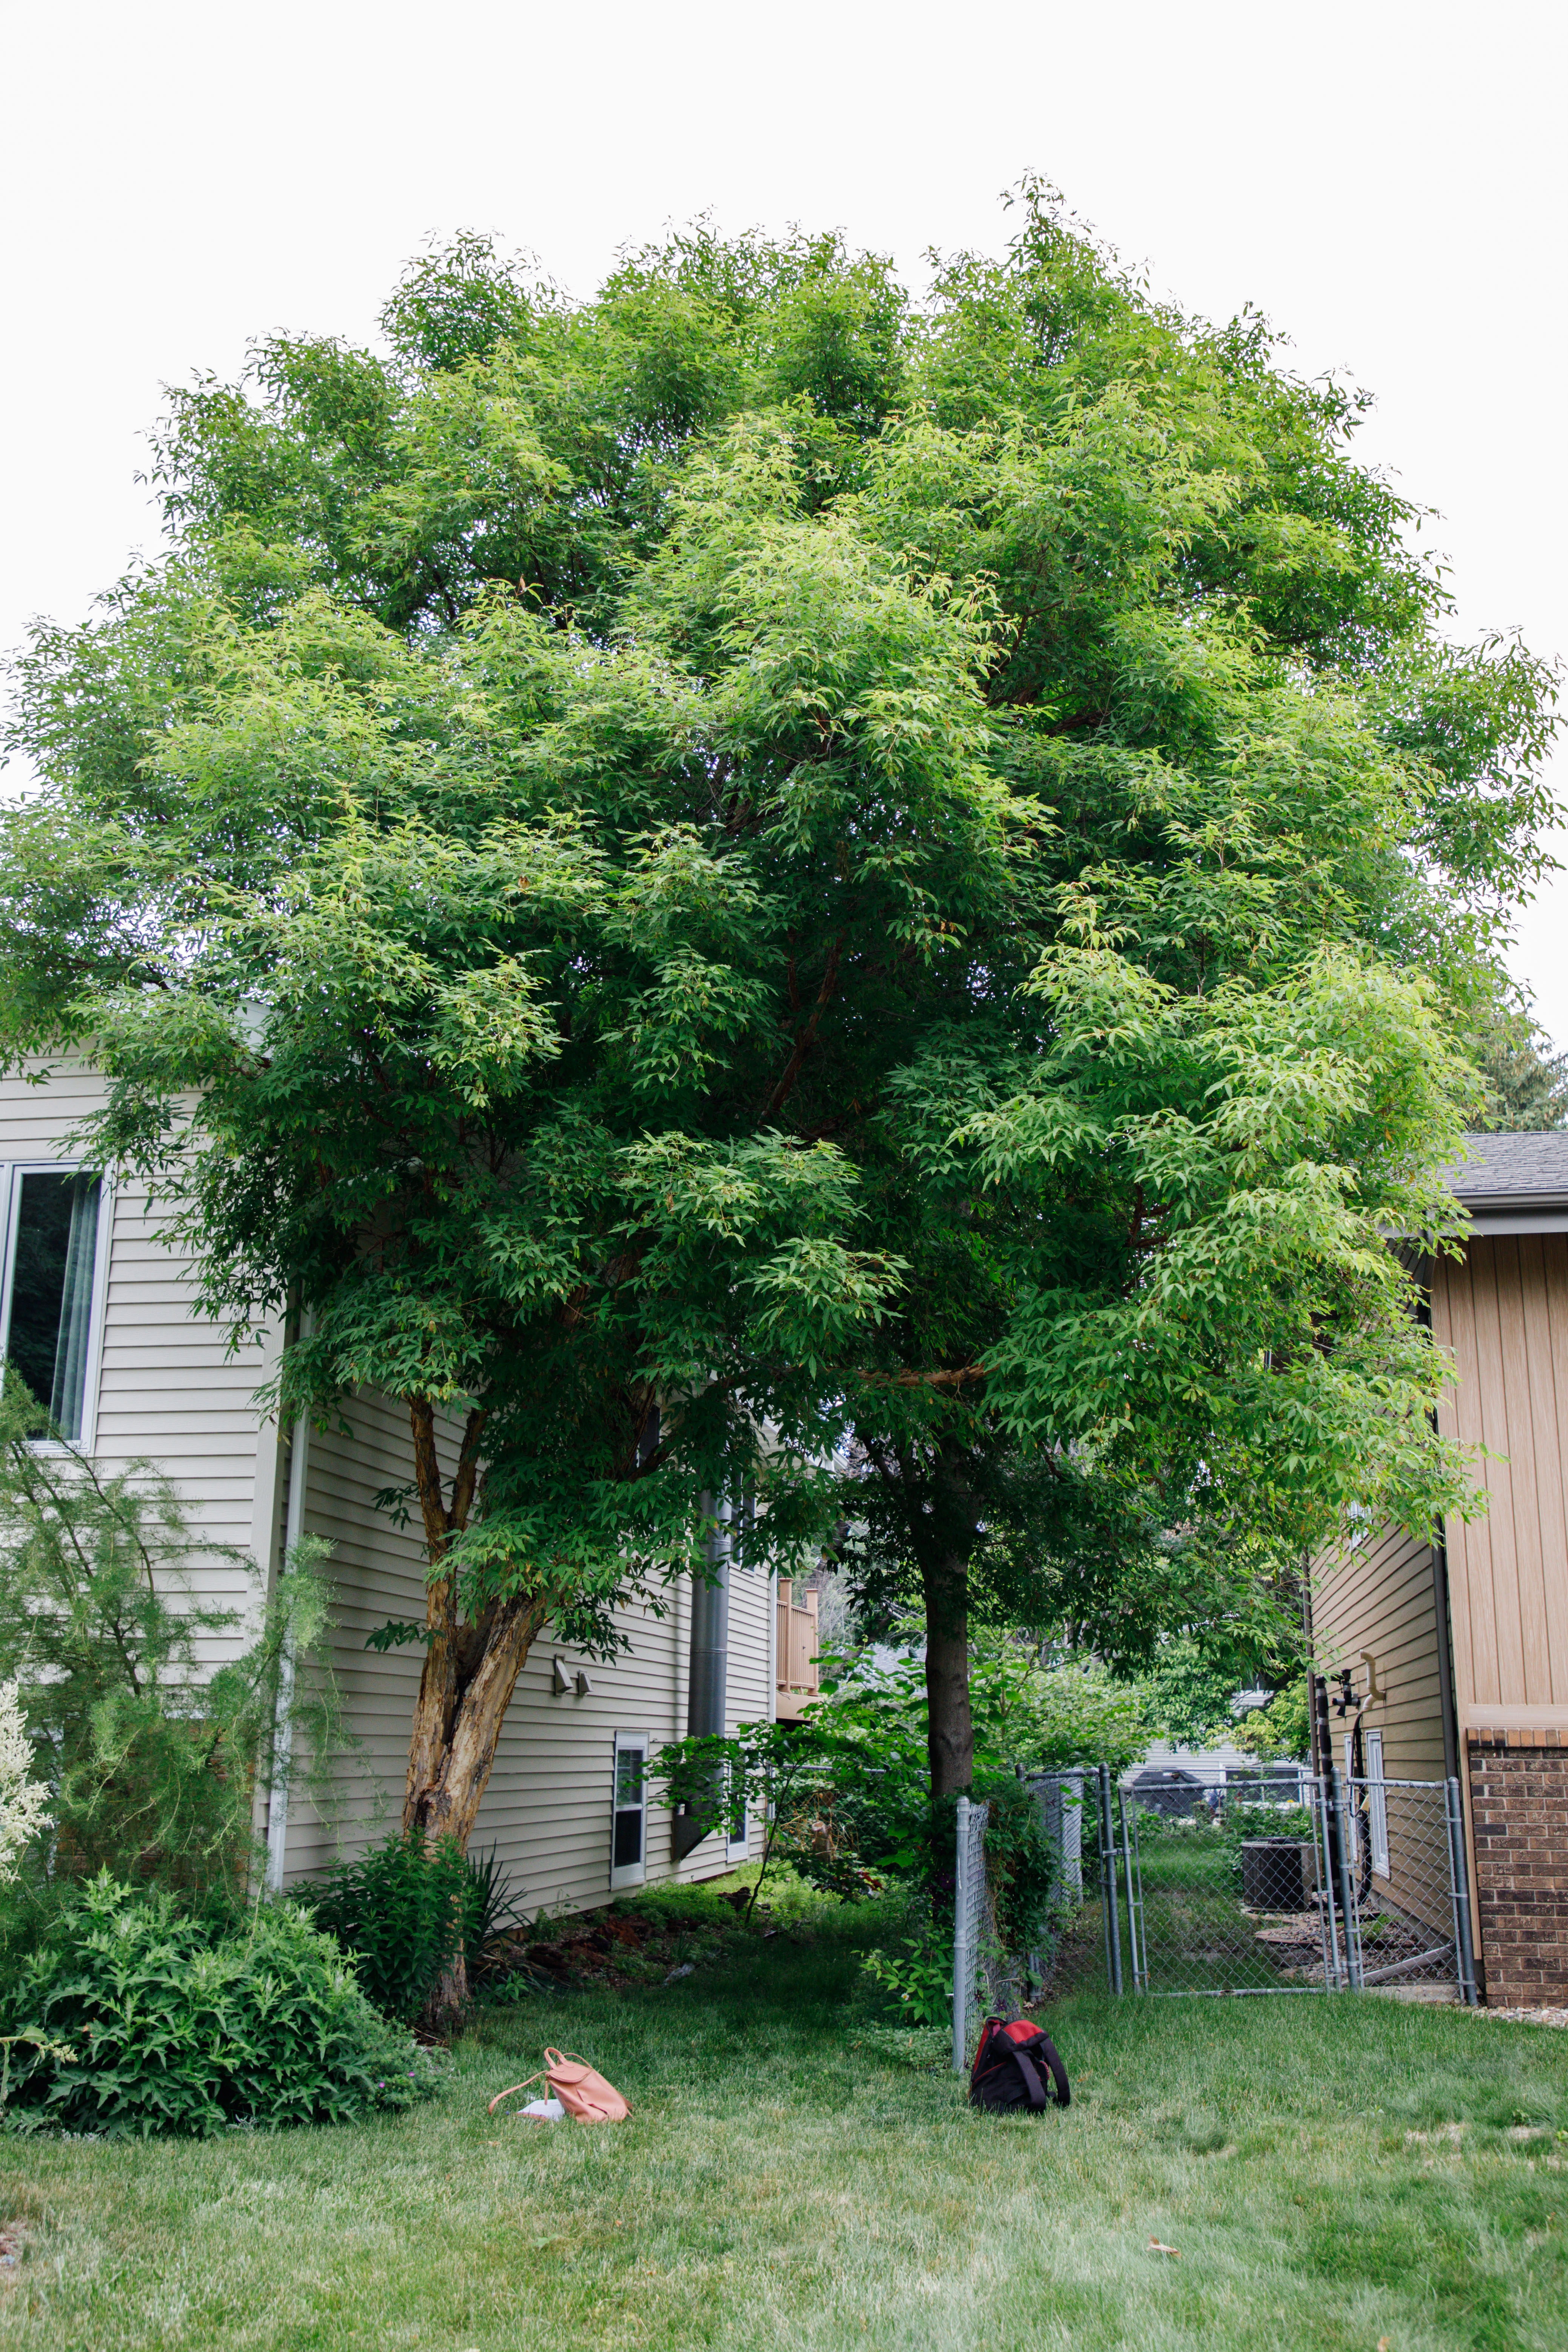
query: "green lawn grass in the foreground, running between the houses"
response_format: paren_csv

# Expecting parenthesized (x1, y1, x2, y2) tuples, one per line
(0, 1896, 1568, 2352)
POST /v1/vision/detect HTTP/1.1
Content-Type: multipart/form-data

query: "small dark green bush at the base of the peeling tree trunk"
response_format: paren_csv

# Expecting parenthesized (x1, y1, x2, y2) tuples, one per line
(313, 1830, 513, 2023)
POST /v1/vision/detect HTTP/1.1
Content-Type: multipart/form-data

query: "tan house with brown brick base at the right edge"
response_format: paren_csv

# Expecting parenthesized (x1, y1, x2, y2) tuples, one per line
(1312, 1134, 1568, 2004)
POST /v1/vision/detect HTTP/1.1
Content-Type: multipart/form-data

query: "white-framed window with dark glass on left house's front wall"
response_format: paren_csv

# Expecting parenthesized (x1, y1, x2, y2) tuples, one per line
(0, 1169, 101, 1439)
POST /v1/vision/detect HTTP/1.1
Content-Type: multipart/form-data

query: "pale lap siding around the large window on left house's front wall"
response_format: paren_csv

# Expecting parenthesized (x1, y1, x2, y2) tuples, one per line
(0, 1068, 273, 1658)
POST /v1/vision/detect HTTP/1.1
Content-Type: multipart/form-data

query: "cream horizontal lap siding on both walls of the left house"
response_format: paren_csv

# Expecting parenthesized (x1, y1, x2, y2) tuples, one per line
(0, 1070, 769, 1910)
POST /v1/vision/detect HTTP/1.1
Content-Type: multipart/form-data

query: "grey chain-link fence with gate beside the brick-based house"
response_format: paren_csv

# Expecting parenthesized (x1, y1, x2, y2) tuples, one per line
(952, 1764, 1476, 2070)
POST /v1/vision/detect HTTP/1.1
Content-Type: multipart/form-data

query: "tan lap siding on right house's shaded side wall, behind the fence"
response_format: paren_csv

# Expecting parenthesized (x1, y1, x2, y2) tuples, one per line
(1312, 1526, 1443, 1781)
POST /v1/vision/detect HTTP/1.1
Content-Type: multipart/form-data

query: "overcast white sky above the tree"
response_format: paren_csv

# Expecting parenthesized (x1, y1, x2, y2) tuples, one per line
(0, 0, 1568, 1044)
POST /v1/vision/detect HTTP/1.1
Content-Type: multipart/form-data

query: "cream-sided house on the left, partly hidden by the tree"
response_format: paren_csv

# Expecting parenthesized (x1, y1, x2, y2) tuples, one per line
(0, 1068, 790, 1910)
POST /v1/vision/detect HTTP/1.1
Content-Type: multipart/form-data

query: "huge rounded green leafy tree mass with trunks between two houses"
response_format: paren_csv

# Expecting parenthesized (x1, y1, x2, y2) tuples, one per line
(0, 188, 1551, 1834)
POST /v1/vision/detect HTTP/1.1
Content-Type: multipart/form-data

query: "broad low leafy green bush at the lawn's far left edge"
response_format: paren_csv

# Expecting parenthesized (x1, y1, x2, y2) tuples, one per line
(0, 1875, 440, 2138)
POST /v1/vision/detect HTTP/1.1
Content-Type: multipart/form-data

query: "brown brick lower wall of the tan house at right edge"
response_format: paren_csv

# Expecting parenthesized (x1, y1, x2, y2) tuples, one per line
(1469, 1731, 1568, 2009)
